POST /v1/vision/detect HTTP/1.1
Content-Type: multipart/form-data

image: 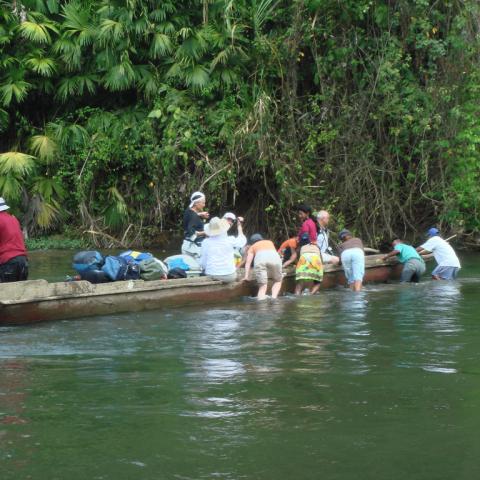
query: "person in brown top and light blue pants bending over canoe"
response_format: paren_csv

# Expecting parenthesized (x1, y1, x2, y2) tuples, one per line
(338, 230, 365, 292)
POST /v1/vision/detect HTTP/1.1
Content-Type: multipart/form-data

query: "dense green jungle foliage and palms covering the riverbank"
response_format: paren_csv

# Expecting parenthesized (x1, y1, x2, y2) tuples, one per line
(0, 0, 480, 246)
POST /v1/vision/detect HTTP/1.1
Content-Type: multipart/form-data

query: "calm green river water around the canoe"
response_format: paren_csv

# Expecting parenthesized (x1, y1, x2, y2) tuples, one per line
(0, 249, 480, 480)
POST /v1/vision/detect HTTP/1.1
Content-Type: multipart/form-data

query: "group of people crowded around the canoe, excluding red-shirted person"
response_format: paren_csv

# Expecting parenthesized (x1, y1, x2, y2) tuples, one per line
(182, 192, 460, 299)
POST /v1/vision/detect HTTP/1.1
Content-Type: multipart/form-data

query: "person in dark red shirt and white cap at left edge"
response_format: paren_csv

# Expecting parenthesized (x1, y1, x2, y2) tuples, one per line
(0, 197, 28, 282)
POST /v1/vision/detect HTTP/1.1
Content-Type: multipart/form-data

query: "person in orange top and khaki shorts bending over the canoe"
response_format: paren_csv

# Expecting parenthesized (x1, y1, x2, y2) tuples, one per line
(243, 233, 283, 300)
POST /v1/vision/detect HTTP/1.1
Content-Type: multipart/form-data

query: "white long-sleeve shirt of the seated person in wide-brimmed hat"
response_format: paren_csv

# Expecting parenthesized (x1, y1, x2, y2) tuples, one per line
(200, 233, 235, 275)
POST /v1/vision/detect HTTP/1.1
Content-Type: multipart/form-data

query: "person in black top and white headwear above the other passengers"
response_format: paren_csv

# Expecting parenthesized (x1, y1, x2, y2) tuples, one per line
(182, 192, 209, 258)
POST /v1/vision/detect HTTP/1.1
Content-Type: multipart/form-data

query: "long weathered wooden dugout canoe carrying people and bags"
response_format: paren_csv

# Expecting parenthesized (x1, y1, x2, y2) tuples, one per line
(0, 255, 401, 325)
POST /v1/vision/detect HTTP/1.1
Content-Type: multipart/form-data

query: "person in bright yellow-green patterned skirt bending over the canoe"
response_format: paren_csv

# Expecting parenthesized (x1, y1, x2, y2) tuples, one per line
(295, 233, 323, 295)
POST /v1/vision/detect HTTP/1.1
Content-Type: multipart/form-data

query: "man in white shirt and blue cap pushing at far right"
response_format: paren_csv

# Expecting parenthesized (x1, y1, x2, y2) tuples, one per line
(417, 227, 461, 280)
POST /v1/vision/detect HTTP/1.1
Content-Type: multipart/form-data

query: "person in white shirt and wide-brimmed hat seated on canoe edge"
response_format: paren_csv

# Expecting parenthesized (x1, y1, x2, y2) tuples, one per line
(200, 217, 237, 283)
